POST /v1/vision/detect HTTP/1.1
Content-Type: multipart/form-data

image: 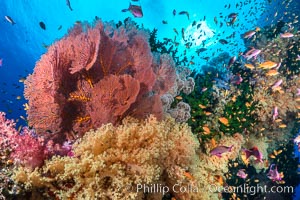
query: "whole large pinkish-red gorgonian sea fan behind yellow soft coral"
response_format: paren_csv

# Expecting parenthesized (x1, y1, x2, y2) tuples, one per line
(24, 20, 176, 141)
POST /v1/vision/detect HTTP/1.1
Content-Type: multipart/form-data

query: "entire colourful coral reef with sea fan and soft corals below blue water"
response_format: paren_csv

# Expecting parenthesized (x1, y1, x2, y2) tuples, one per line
(0, 12, 300, 200)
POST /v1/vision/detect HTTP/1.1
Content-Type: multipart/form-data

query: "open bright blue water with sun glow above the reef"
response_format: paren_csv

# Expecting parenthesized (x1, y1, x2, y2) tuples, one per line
(0, 0, 300, 199)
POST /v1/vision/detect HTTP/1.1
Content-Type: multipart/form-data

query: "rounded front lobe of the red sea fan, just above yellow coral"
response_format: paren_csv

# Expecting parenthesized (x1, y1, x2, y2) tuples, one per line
(87, 75, 140, 131)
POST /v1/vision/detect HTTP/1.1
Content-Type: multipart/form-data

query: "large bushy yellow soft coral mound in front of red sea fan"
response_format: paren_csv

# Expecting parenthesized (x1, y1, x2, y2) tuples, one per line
(15, 116, 199, 199)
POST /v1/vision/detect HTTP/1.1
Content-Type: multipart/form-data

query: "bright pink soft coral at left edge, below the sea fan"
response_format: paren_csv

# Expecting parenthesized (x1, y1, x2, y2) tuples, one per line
(0, 112, 66, 169)
